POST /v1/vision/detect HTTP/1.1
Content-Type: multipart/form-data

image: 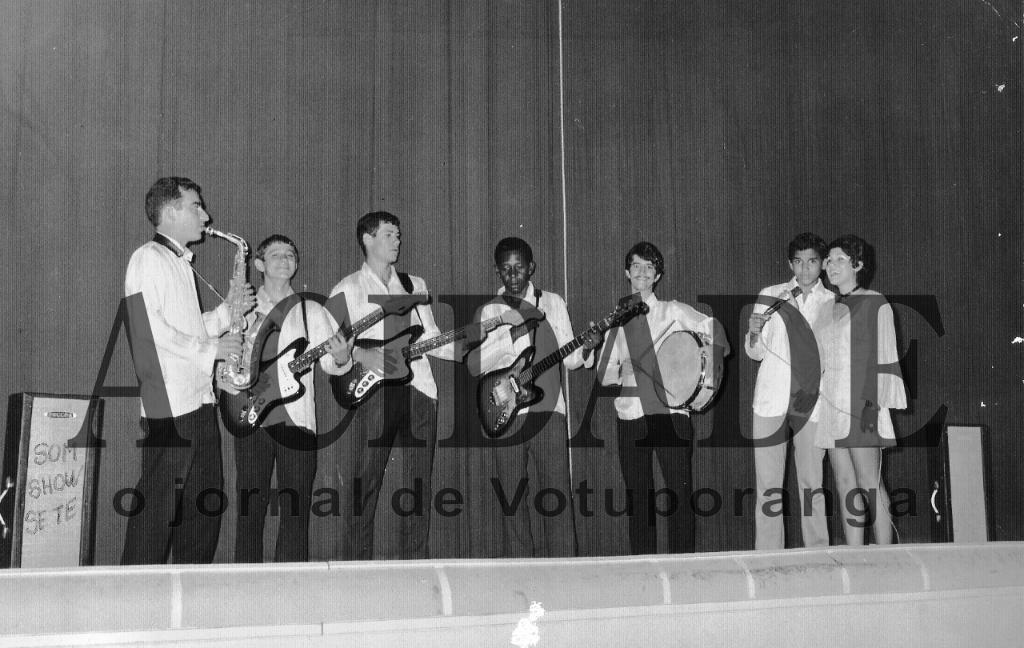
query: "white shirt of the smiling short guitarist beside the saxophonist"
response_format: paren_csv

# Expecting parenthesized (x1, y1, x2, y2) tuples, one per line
(247, 286, 352, 432)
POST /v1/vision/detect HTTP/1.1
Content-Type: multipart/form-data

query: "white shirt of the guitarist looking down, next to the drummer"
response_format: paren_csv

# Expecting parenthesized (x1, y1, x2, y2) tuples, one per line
(467, 282, 595, 416)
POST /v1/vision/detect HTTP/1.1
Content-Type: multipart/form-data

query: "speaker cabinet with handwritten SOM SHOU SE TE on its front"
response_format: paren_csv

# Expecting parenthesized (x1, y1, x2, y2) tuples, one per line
(0, 394, 101, 567)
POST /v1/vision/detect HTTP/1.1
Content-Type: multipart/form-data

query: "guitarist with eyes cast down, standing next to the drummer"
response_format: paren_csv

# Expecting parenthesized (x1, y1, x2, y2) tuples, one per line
(467, 236, 602, 558)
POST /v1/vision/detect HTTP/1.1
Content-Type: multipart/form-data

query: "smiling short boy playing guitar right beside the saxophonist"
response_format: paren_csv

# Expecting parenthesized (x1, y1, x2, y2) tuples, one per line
(221, 234, 351, 562)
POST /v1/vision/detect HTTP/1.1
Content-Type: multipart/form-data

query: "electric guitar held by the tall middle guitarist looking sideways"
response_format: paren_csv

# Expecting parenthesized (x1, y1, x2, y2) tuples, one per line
(331, 308, 544, 407)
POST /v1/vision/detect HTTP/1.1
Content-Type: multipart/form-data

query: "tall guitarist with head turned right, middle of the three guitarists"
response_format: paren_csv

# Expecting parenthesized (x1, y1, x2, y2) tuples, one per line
(330, 212, 486, 560)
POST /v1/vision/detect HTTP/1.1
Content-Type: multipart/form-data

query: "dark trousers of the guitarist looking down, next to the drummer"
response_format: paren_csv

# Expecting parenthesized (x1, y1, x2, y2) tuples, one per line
(494, 413, 577, 558)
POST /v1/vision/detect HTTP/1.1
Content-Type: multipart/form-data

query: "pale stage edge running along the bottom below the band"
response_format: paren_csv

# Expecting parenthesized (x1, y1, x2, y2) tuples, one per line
(0, 543, 1024, 648)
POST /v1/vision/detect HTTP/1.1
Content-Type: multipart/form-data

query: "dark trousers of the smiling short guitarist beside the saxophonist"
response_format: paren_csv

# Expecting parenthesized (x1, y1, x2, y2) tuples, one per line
(234, 423, 316, 562)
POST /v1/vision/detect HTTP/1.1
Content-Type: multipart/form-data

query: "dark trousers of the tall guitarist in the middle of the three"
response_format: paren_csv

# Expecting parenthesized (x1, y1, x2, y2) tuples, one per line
(339, 385, 437, 560)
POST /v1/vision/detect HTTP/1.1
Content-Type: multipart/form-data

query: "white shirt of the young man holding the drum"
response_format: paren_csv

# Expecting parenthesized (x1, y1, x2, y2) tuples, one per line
(601, 293, 729, 421)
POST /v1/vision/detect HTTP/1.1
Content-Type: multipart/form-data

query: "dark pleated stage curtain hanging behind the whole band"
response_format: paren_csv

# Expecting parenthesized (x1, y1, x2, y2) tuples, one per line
(0, 0, 1024, 563)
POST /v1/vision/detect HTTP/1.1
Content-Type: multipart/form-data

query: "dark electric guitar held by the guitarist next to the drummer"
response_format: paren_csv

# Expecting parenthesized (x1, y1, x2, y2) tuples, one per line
(476, 301, 649, 437)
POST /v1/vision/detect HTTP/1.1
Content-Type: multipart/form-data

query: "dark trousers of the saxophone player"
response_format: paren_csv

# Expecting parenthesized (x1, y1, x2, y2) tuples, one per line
(121, 404, 223, 565)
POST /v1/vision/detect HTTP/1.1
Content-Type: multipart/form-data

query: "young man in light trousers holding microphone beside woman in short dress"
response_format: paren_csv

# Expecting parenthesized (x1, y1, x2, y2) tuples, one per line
(743, 232, 835, 549)
